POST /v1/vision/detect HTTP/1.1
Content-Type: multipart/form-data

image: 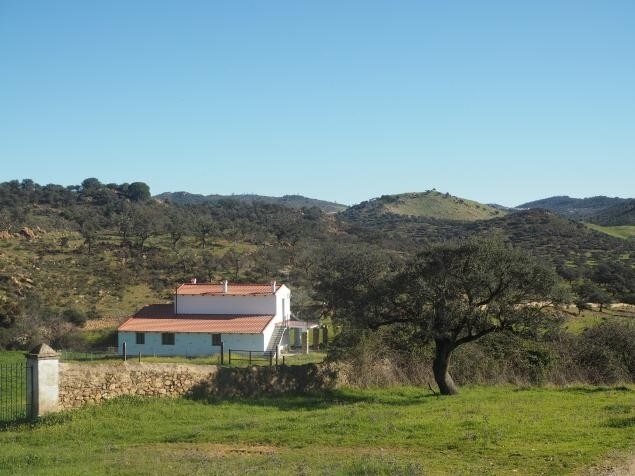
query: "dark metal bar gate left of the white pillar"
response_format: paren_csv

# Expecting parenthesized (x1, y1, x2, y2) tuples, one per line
(0, 362, 33, 425)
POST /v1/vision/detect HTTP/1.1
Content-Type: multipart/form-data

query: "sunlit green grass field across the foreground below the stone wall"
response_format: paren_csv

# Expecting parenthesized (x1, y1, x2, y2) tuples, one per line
(0, 387, 635, 475)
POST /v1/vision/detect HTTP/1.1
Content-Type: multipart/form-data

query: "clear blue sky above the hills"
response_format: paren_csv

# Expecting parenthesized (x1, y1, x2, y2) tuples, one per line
(0, 0, 635, 205)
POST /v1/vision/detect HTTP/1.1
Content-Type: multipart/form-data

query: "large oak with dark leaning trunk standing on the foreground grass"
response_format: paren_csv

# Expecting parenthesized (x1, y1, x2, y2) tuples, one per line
(395, 240, 564, 395)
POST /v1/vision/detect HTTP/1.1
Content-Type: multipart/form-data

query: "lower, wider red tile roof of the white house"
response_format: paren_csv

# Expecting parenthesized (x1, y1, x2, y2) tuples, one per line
(118, 304, 273, 334)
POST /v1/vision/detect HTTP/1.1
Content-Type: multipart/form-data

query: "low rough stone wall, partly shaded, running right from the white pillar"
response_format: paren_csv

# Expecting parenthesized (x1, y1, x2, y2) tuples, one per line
(59, 362, 336, 410)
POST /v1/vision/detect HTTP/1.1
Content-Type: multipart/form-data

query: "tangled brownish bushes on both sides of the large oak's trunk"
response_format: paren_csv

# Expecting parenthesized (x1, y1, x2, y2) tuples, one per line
(329, 321, 635, 387)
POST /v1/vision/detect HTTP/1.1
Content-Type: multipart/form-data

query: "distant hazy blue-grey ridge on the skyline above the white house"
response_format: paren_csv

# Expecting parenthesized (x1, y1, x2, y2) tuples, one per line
(154, 192, 347, 213)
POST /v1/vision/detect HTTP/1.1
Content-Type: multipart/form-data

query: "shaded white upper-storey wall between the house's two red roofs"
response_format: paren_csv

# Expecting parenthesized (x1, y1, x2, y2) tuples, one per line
(175, 294, 277, 315)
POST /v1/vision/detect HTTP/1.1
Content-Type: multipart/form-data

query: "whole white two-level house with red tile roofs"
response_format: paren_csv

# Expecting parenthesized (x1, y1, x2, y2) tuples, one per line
(118, 281, 291, 356)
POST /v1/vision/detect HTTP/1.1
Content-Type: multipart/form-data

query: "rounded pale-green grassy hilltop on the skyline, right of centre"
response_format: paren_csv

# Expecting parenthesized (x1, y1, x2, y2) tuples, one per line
(343, 190, 505, 222)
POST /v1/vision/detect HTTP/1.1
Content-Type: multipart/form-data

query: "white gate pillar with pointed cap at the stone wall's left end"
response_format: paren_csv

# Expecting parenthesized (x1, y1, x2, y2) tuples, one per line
(26, 344, 60, 418)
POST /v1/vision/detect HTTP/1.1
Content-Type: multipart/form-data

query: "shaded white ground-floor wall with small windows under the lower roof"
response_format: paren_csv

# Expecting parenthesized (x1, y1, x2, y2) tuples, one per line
(118, 331, 269, 356)
